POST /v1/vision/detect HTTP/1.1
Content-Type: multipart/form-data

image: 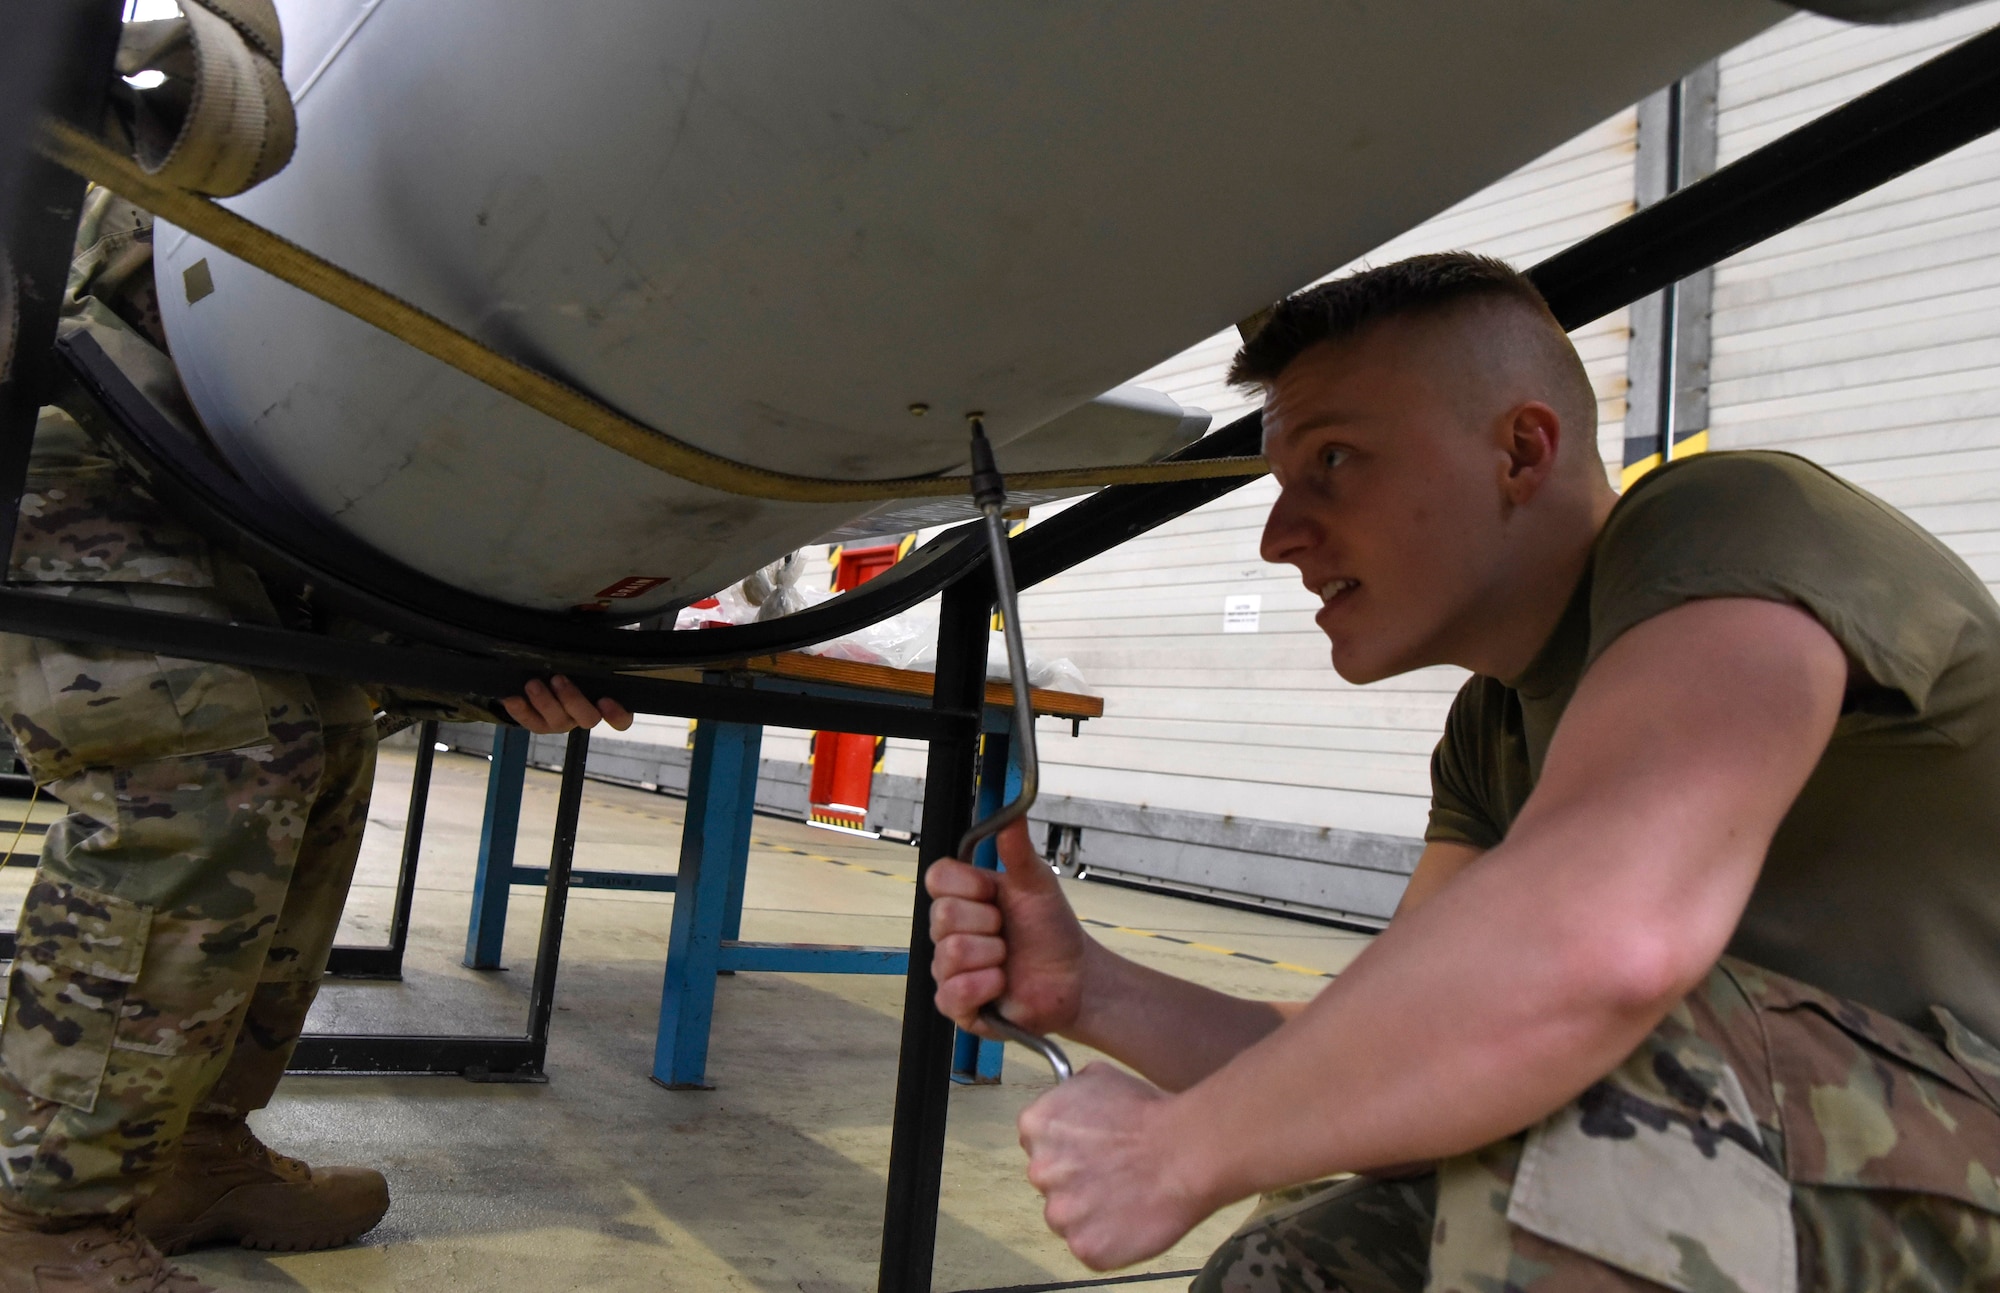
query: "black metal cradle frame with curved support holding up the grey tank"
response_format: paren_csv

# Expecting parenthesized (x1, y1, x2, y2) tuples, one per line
(0, 17, 2000, 1293)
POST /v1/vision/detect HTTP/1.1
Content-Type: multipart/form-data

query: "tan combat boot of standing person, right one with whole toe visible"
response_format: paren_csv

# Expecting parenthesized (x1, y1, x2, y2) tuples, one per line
(134, 1115, 388, 1253)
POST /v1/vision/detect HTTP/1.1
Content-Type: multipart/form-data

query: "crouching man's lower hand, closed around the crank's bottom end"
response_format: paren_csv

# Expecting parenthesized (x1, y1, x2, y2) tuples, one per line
(1016, 1063, 1200, 1271)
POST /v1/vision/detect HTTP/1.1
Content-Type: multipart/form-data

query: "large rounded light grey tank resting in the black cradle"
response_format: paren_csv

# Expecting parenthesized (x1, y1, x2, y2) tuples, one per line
(158, 0, 1786, 612)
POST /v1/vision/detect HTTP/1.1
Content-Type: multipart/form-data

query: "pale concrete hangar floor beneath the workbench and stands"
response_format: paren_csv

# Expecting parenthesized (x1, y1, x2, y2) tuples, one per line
(0, 749, 1366, 1293)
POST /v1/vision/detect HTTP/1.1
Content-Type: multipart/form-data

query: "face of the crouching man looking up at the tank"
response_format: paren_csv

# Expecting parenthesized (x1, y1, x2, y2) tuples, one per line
(1262, 320, 1508, 683)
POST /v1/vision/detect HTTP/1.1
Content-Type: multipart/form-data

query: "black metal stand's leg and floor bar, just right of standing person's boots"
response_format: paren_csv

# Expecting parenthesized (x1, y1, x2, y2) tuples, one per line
(290, 731, 590, 1083)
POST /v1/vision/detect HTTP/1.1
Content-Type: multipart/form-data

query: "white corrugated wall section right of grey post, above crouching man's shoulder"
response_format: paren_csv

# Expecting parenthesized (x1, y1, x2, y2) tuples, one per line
(1710, 4, 2000, 586)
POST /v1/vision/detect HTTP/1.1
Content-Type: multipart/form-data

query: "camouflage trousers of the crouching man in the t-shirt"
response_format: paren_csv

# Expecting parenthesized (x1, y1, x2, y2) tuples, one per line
(1192, 961, 2000, 1293)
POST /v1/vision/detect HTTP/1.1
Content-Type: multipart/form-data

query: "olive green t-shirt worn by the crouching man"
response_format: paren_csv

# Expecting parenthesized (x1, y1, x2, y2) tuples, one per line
(1424, 452, 2000, 1037)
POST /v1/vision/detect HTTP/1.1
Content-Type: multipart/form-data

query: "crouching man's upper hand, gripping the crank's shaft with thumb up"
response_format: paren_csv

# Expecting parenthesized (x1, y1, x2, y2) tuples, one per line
(924, 823, 1096, 1035)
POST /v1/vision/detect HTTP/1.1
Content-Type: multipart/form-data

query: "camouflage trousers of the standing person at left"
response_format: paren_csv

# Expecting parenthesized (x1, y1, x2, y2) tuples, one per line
(0, 582, 374, 1215)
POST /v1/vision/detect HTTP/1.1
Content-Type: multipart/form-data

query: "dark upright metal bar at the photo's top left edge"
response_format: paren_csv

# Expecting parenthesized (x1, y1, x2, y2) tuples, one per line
(0, 0, 124, 572)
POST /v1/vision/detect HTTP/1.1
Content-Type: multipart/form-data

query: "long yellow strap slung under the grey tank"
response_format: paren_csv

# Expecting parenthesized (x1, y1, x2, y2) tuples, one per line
(40, 120, 1268, 502)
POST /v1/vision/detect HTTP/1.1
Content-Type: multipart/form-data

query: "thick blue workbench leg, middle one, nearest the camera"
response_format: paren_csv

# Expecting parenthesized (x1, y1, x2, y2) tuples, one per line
(652, 719, 764, 1089)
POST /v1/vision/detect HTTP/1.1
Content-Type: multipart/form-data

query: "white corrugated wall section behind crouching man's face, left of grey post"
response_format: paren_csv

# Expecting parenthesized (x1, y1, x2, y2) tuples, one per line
(1022, 112, 1636, 837)
